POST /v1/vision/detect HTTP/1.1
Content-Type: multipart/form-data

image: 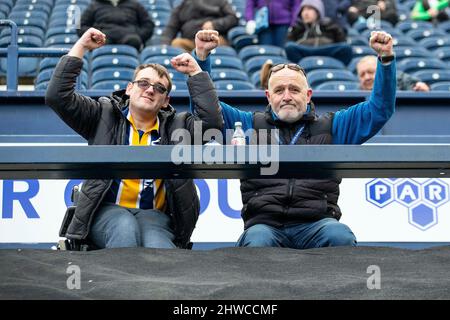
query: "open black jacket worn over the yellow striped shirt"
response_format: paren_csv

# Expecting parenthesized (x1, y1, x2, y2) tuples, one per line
(45, 56, 223, 248)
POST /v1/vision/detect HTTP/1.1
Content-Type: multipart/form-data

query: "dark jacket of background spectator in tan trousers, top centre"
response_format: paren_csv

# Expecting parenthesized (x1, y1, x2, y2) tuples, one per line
(161, 0, 239, 44)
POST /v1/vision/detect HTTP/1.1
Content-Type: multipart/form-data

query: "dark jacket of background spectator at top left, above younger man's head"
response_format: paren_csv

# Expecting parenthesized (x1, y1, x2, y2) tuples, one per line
(78, 0, 155, 43)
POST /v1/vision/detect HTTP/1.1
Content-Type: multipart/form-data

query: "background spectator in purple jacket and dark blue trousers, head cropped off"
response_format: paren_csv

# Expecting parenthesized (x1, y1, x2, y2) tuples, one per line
(245, 0, 301, 47)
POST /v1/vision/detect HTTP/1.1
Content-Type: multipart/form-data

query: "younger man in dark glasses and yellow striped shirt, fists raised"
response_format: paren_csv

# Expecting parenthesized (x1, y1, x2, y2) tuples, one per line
(45, 28, 222, 248)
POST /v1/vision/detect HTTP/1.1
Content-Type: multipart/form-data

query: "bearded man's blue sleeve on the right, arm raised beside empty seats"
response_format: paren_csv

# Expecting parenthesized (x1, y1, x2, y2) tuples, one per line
(331, 60, 397, 144)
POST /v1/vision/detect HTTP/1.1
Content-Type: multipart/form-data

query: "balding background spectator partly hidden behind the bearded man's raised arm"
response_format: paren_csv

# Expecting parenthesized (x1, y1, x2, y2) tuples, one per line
(356, 56, 430, 92)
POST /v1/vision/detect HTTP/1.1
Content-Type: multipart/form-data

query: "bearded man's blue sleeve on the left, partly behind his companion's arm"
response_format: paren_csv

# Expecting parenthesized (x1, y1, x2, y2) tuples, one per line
(191, 53, 253, 132)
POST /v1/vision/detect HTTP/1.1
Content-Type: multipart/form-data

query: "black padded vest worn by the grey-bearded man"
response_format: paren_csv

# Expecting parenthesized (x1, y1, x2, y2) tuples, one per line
(241, 105, 341, 229)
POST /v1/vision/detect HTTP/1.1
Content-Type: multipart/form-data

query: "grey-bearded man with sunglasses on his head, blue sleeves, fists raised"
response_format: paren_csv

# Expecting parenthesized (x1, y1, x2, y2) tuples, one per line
(196, 31, 396, 249)
